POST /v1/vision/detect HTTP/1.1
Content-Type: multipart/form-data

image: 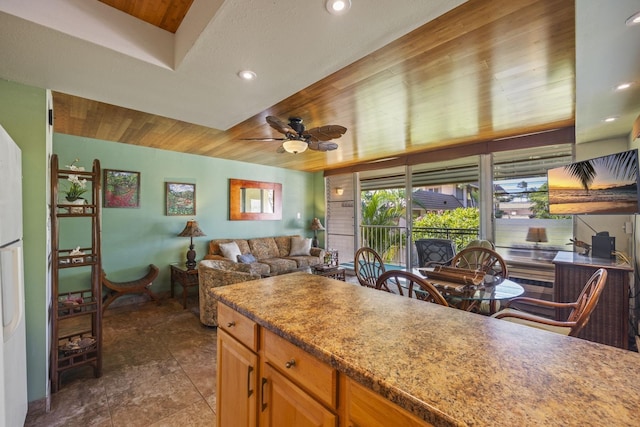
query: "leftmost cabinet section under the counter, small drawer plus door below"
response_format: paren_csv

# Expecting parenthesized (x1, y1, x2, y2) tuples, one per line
(216, 305, 259, 427)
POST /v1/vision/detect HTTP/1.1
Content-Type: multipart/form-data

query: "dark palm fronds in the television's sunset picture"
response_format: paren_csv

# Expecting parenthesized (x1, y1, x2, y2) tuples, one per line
(565, 150, 638, 194)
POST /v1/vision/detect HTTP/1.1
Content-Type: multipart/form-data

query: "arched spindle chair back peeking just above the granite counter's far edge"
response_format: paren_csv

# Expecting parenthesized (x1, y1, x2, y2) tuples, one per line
(376, 270, 449, 306)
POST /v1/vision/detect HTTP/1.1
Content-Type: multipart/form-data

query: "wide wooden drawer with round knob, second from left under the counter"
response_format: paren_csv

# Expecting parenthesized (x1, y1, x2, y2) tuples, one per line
(262, 330, 337, 409)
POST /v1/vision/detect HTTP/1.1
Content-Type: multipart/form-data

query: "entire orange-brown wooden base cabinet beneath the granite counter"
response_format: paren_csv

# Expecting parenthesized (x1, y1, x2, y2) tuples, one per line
(217, 303, 430, 427)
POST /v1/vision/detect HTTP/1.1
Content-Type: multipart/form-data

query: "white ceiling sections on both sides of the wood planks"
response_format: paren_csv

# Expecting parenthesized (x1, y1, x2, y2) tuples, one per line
(0, 0, 640, 147)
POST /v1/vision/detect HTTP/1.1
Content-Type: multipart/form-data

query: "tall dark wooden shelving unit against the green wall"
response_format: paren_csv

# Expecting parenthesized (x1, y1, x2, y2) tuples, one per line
(51, 154, 102, 392)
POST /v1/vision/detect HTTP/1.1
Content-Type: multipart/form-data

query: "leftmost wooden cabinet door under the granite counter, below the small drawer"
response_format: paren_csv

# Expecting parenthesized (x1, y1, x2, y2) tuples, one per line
(216, 328, 258, 427)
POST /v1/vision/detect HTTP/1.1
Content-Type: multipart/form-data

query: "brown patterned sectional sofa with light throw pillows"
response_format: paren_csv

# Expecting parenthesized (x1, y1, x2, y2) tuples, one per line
(198, 235, 325, 326)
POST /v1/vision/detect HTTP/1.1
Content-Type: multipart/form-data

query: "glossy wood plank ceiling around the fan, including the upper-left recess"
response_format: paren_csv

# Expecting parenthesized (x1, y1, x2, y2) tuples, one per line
(54, 0, 575, 172)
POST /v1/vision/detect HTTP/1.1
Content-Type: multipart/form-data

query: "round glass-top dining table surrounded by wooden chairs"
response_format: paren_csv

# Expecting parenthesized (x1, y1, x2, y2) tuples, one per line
(413, 268, 524, 314)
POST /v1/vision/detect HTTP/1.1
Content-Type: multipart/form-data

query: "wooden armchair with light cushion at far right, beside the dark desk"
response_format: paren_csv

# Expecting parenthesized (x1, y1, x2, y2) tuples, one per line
(492, 268, 607, 337)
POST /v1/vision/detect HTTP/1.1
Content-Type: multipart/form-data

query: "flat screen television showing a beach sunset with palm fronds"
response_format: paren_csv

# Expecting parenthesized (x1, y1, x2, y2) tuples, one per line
(547, 150, 640, 215)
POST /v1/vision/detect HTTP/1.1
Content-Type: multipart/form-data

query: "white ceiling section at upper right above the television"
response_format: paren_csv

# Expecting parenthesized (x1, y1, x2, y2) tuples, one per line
(576, 0, 640, 143)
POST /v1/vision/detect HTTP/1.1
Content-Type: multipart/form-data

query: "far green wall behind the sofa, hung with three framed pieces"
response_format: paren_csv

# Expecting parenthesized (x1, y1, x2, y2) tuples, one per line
(53, 134, 324, 292)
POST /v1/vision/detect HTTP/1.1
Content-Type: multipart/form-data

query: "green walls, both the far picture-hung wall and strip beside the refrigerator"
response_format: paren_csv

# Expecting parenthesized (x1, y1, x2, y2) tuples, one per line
(0, 80, 325, 402)
